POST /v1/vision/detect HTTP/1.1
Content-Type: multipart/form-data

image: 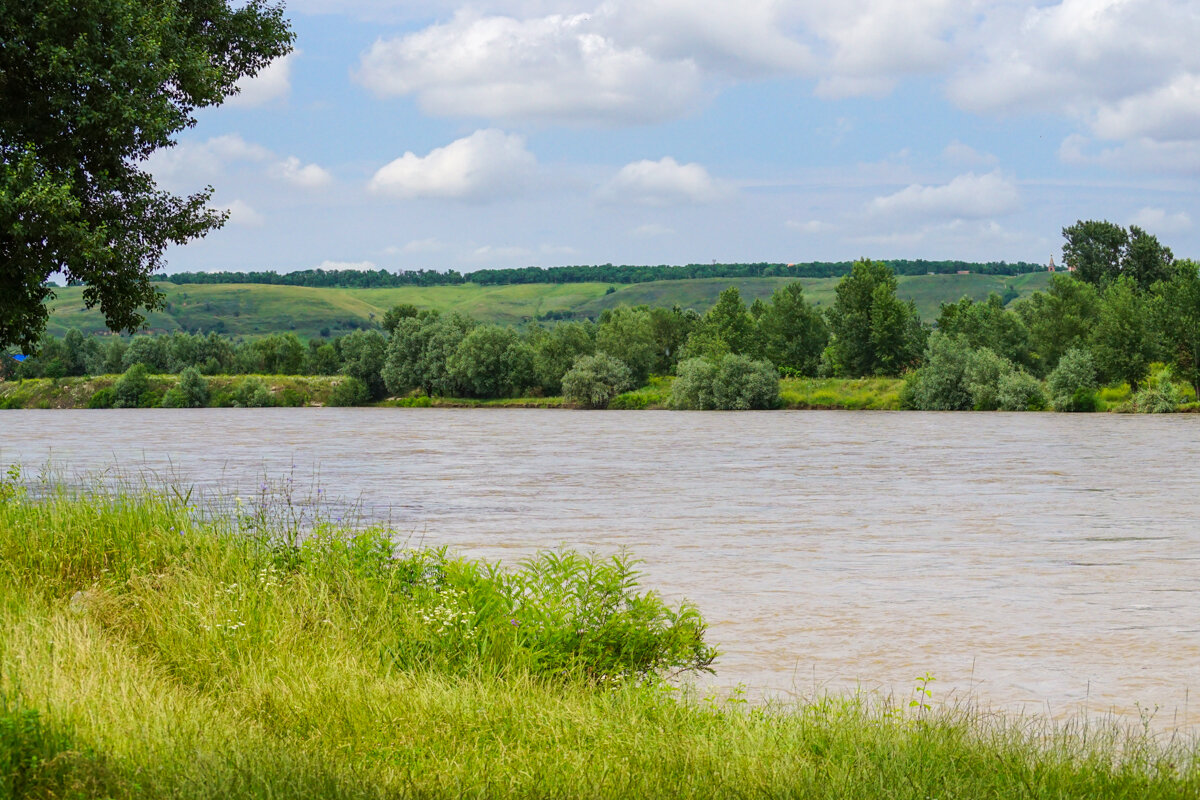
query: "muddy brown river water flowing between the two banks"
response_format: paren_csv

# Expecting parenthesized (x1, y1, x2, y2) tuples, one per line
(0, 409, 1200, 727)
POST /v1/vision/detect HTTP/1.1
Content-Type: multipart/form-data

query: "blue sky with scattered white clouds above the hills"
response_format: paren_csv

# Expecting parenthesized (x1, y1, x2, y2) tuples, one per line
(149, 0, 1200, 272)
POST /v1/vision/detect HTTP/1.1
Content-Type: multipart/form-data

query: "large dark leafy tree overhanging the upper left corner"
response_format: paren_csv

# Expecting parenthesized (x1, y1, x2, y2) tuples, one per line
(0, 0, 293, 349)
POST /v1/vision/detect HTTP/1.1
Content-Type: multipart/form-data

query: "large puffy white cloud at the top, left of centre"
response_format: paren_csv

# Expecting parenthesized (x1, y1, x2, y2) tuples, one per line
(359, 13, 704, 122)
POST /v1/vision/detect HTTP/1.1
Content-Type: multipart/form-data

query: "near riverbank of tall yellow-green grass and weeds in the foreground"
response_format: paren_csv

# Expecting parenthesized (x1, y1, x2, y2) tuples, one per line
(0, 480, 1200, 799)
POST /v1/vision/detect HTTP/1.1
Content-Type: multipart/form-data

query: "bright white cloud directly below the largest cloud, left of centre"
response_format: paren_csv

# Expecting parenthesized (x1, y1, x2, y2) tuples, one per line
(368, 128, 538, 201)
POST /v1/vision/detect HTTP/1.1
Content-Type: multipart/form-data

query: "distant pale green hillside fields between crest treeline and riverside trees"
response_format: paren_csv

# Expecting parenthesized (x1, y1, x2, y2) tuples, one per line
(47, 272, 1048, 337)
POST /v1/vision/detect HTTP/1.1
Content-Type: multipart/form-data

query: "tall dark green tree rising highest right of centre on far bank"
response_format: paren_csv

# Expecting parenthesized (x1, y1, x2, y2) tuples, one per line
(826, 259, 925, 378)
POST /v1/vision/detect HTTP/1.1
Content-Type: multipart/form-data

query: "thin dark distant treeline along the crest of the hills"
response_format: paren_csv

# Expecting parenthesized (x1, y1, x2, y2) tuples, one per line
(157, 260, 1045, 289)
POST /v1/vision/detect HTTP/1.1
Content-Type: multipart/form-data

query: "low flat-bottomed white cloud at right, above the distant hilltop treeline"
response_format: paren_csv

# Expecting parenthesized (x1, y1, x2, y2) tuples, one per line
(869, 170, 1020, 219)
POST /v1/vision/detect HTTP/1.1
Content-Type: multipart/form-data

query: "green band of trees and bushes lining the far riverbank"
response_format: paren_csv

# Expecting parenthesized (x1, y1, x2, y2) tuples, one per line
(16, 222, 1200, 410)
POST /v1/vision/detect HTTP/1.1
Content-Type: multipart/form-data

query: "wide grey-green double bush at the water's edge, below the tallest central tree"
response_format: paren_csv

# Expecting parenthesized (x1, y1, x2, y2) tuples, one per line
(670, 354, 779, 410)
